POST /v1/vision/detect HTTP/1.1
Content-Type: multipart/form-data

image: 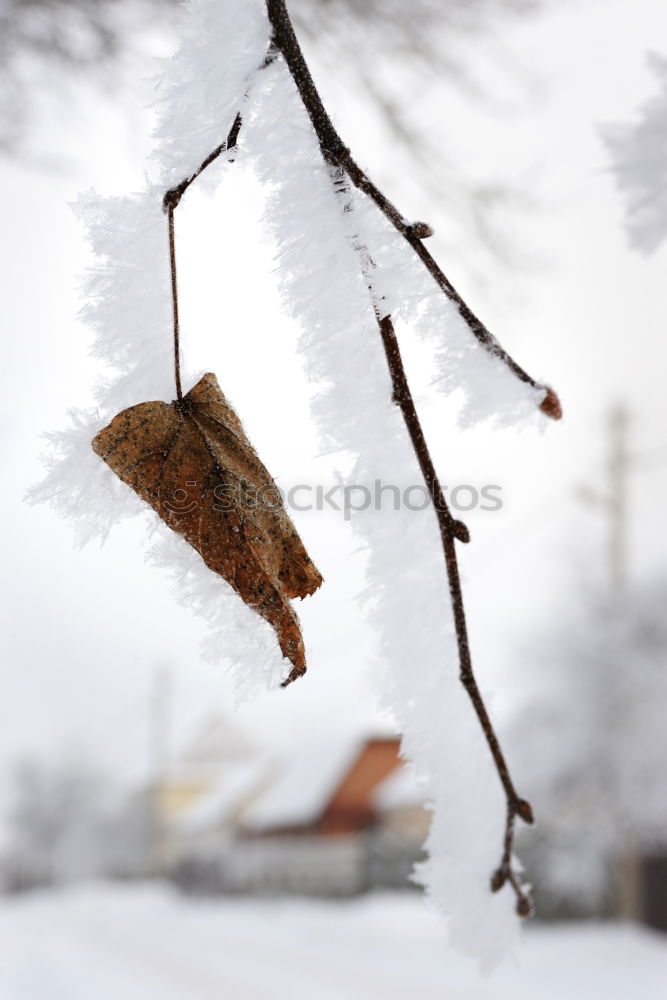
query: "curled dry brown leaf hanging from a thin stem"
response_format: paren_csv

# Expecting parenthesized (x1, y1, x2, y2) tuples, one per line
(93, 374, 322, 686)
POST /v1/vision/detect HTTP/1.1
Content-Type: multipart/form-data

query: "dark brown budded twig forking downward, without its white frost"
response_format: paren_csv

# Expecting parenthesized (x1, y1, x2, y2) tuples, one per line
(163, 0, 561, 916)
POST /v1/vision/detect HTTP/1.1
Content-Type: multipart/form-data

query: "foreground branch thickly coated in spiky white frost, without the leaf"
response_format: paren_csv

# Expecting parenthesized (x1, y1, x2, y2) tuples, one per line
(32, 0, 560, 965)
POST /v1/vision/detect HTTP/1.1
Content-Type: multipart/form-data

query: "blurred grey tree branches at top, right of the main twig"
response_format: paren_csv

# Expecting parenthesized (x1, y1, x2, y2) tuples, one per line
(290, 0, 543, 263)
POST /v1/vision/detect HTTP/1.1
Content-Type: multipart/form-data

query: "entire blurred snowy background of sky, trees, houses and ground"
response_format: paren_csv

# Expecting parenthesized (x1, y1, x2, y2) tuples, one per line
(0, 0, 667, 1000)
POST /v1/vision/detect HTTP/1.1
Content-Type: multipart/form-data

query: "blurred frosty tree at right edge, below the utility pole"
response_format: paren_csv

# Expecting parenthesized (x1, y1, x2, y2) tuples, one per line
(514, 580, 667, 916)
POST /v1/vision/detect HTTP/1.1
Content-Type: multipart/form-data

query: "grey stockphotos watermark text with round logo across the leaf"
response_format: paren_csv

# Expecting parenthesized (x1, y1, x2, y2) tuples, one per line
(161, 479, 503, 521)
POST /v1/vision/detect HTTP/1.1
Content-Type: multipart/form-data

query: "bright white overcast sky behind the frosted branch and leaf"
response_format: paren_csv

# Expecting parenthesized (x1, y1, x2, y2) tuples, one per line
(0, 0, 667, 796)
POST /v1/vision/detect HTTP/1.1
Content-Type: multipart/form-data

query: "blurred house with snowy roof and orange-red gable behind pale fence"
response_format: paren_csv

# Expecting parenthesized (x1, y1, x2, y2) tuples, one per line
(166, 737, 429, 896)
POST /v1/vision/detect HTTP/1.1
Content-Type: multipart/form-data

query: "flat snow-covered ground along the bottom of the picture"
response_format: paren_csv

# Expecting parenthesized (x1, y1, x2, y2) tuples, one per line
(0, 886, 667, 1000)
